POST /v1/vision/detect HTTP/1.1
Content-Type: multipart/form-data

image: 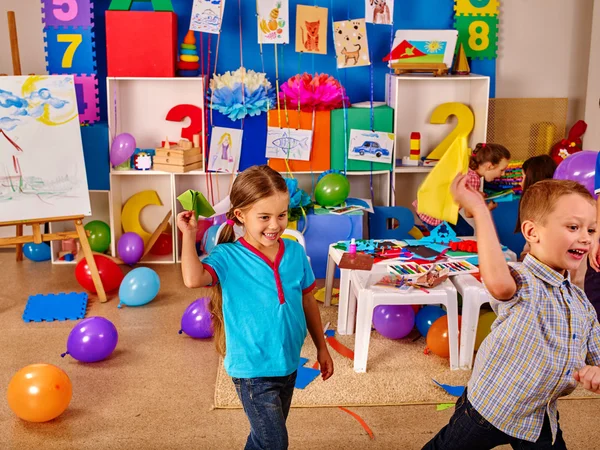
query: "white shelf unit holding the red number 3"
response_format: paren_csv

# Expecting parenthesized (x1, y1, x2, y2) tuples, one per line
(106, 77, 206, 263)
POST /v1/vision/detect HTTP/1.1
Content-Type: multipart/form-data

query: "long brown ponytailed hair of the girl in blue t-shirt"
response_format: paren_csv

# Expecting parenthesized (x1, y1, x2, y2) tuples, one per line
(209, 166, 288, 355)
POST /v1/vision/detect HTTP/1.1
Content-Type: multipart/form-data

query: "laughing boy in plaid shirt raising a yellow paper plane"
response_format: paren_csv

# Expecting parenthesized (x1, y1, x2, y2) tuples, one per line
(423, 176, 600, 450)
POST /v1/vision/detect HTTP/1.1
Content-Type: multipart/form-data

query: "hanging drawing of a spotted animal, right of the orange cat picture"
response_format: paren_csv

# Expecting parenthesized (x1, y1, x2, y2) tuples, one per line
(333, 19, 371, 69)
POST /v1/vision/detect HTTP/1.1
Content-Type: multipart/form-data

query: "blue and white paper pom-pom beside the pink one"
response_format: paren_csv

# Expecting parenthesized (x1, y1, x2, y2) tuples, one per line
(207, 67, 275, 120)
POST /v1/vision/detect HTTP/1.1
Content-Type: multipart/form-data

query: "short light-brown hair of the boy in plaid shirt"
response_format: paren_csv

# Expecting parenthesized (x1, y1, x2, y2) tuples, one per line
(519, 179, 595, 229)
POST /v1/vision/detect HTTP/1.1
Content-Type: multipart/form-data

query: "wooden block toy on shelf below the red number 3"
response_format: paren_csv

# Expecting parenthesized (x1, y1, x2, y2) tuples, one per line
(154, 134, 204, 173)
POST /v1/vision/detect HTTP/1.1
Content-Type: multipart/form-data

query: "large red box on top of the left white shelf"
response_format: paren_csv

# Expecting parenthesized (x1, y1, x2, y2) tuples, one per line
(106, 11, 177, 77)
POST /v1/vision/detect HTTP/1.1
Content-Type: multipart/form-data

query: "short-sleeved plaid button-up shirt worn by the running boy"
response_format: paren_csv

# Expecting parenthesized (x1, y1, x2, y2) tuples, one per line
(468, 255, 600, 442)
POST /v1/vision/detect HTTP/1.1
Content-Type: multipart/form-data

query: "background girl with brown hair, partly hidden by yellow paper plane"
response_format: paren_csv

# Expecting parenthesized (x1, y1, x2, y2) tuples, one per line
(413, 143, 510, 236)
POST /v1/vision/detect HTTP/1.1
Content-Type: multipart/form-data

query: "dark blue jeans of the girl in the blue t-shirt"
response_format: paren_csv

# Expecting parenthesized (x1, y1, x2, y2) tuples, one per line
(232, 371, 297, 450)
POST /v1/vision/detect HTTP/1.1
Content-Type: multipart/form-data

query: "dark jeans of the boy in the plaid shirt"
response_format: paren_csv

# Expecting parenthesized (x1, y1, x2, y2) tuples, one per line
(423, 389, 567, 450)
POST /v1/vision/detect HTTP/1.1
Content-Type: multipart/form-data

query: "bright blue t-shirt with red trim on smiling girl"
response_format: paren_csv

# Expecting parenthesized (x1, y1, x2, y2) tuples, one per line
(203, 238, 315, 378)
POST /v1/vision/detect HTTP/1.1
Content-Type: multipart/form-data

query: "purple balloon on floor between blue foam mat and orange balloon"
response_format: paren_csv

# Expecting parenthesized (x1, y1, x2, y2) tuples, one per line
(61, 317, 119, 362)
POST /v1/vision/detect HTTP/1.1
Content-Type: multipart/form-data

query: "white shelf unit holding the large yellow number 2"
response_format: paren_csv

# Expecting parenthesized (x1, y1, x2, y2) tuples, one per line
(385, 74, 490, 213)
